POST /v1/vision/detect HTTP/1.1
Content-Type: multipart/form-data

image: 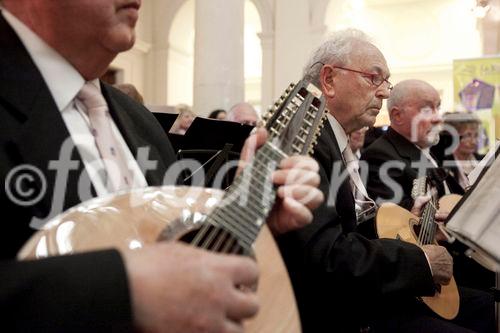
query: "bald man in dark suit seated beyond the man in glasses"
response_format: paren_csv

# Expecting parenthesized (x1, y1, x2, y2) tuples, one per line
(361, 80, 495, 290)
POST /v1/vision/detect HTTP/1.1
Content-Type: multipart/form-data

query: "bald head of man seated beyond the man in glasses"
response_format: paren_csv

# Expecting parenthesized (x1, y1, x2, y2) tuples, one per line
(387, 80, 442, 148)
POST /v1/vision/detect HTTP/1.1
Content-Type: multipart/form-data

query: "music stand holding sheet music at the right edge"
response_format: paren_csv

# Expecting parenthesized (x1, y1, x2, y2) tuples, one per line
(446, 146, 500, 332)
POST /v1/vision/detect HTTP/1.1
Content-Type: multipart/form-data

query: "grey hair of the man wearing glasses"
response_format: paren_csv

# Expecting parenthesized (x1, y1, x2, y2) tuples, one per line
(304, 28, 372, 87)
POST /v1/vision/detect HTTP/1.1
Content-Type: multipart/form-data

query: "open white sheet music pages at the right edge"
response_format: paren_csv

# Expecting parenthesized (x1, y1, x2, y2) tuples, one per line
(446, 149, 500, 270)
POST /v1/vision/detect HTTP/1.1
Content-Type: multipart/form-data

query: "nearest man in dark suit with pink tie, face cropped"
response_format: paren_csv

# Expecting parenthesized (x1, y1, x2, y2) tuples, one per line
(0, 0, 321, 332)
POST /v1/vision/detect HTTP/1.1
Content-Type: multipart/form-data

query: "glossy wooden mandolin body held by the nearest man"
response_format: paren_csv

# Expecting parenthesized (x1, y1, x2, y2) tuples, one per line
(18, 186, 301, 333)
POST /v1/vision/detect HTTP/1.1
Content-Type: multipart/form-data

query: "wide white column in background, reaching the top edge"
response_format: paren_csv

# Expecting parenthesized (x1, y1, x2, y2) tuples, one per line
(193, 0, 245, 115)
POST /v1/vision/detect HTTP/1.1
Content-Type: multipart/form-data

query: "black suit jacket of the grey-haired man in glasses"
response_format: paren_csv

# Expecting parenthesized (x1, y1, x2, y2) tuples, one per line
(278, 123, 433, 332)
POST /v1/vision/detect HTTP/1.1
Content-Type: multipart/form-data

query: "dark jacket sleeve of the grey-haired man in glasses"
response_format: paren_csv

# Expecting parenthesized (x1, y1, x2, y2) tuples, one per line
(288, 160, 434, 298)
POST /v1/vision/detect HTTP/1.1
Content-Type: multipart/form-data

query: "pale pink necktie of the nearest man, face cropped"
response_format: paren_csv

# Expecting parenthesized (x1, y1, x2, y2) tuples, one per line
(77, 82, 133, 191)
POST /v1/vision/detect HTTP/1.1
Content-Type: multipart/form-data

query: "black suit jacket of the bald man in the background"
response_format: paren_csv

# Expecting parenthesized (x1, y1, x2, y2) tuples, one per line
(361, 127, 463, 209)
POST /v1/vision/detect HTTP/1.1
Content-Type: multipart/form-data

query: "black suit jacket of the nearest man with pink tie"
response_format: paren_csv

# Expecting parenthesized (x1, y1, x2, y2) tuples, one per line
(0, 15, 175, 332)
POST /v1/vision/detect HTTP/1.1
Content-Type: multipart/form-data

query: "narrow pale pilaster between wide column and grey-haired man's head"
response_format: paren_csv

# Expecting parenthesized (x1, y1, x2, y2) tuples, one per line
(259, 33, 275, 112)
